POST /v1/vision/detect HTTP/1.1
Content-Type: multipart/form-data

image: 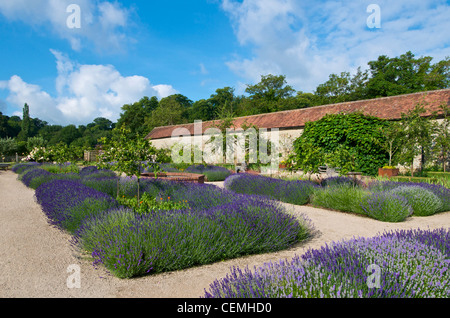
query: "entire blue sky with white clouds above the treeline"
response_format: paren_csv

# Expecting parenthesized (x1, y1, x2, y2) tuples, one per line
(0, 0, 450, 125)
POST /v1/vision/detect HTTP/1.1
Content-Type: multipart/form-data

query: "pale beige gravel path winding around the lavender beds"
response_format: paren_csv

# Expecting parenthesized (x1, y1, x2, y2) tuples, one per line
(0, 171, 450, 298)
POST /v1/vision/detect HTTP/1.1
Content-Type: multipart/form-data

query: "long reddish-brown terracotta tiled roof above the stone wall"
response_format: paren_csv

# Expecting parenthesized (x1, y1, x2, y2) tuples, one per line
(146, 89, 450, 139)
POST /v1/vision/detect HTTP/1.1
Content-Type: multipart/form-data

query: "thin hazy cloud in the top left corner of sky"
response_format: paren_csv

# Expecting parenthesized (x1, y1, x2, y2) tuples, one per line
(0, 0, 131, 51)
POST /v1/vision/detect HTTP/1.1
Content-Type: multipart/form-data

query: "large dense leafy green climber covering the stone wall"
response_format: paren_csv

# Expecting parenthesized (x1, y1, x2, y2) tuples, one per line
(290, 112, 388, 175)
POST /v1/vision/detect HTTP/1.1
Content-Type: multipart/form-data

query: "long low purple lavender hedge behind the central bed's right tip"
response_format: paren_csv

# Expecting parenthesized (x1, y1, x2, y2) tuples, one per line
(224, 173, 320, 205)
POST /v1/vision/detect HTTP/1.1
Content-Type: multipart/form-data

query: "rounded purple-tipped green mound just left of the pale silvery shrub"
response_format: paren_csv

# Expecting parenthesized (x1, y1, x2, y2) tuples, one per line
(360, 192, 413, 222)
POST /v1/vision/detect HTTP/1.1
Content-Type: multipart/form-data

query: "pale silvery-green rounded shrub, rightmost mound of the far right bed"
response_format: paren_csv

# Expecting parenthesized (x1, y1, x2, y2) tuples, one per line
(391, 186, 442, 216)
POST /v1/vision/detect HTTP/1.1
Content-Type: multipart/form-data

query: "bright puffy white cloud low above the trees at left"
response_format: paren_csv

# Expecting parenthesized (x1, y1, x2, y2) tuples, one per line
(0, 50, 177, 125)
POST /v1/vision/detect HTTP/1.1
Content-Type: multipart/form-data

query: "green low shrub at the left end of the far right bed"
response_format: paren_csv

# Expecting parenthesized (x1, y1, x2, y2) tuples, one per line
(311, 184, 369, 214)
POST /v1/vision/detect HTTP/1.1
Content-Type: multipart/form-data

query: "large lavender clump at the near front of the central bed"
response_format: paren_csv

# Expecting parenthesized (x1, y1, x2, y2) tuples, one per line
(75, 196, 309, 278)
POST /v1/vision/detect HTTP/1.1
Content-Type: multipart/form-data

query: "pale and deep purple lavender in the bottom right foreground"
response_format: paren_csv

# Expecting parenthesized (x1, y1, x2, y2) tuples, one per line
(204, 229, 450, 298)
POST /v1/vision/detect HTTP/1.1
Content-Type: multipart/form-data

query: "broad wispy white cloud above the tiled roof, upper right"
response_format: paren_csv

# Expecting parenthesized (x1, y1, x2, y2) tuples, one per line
(222, 0, 450, 91)
